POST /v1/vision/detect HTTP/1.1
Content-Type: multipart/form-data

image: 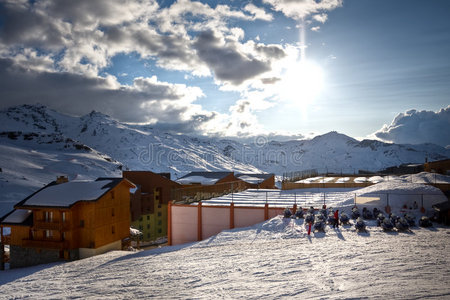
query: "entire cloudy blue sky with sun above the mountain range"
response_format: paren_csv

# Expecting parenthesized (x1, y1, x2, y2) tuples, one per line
(0, 0, 450, 146)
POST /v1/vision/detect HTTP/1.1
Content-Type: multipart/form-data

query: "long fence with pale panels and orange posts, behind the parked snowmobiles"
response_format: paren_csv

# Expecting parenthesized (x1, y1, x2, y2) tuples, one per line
(168, 190, 446, 245)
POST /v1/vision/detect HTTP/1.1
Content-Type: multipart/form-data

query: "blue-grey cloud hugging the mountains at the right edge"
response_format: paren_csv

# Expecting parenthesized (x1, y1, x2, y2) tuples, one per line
(373, 105, 450, 147)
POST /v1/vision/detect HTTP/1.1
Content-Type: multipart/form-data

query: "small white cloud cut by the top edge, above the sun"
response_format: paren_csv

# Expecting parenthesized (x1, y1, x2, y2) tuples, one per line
(263, 0, 342, 19)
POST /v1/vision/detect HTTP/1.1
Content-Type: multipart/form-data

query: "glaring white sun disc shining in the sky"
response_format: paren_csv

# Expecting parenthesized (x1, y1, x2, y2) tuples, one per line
(280, 60, 324, 107)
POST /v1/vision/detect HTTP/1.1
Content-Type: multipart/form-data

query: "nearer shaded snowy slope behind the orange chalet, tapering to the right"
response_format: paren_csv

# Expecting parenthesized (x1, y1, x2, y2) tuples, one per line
(0, 134, 122, 216)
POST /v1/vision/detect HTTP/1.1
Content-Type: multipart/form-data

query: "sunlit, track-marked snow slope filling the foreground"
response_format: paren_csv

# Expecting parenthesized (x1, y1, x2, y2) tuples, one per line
(0, 216, 450, 299)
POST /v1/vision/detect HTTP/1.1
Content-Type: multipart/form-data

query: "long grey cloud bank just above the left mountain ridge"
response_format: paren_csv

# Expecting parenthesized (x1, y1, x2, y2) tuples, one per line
(0, 59, 207, 123)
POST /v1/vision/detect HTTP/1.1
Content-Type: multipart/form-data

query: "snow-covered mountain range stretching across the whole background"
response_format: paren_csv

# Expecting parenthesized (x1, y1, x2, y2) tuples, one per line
(0, 105, 450, 214)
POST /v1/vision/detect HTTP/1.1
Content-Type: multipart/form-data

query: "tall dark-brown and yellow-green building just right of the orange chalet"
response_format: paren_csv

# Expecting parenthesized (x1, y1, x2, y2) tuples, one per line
(122, 171, 181, 241)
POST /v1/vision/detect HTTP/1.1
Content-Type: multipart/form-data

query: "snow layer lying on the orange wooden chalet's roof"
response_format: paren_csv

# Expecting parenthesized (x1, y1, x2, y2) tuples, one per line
(23, 180, 112, 207)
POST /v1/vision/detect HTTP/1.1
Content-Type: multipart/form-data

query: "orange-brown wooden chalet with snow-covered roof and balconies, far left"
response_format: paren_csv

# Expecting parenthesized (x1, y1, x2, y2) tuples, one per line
(0, 177, 135, 268)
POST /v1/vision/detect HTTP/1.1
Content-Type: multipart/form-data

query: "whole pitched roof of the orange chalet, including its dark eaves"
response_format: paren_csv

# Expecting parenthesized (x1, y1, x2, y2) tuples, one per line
(14, 178, 134, 208)
